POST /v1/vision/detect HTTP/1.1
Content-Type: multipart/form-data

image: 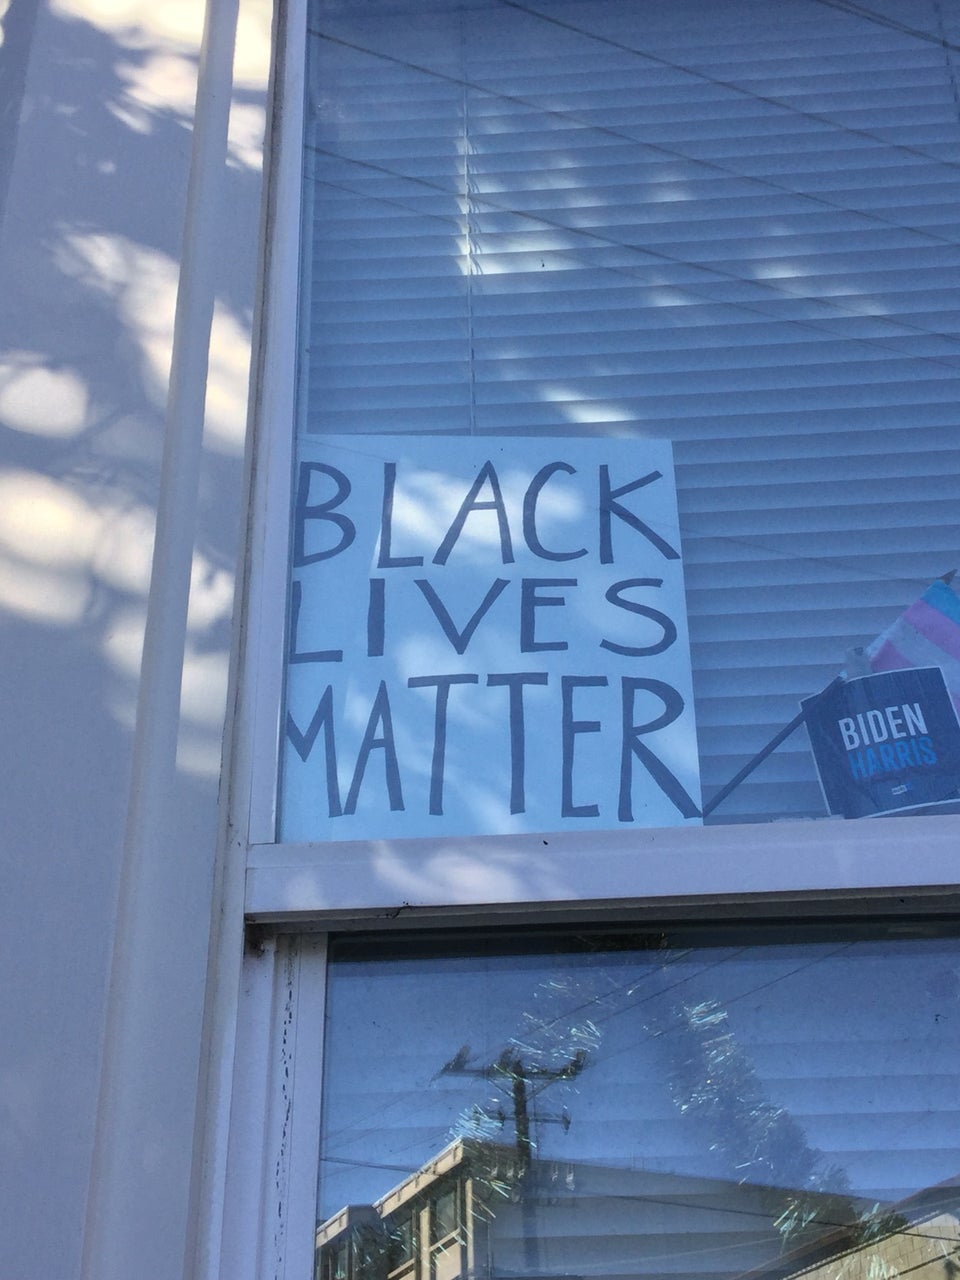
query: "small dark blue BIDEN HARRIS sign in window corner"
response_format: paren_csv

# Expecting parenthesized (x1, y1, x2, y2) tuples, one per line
(800, 667, 960, 818)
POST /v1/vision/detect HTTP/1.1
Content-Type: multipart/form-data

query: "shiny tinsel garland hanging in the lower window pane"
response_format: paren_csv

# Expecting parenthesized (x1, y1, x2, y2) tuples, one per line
(442, 962, 902, 1248)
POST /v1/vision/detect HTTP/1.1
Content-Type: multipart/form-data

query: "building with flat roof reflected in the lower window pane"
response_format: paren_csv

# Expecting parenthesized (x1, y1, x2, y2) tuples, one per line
(316, 1140, 960, 1280)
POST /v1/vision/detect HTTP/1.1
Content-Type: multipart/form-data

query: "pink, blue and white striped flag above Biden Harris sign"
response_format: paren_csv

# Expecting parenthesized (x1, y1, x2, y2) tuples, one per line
(865, 573, 960, 714)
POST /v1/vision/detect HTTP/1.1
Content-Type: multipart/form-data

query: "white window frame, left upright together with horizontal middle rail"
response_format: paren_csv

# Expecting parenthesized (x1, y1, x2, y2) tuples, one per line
(204, 0, 960, 1280)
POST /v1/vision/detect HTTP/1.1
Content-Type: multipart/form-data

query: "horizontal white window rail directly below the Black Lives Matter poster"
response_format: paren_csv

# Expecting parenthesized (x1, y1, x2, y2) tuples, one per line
(246, 815, 957, 922)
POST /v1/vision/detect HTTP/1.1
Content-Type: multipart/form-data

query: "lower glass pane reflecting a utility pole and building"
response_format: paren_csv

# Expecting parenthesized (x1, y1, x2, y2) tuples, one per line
(317, 925, 960, 1280)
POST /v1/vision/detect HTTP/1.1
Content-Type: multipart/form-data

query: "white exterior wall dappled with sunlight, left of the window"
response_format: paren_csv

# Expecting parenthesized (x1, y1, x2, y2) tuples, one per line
(0, 0, 273, 1280)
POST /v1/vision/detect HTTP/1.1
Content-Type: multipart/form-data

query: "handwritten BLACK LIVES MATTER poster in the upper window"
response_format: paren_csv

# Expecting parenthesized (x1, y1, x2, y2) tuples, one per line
(279, 436, 700, 841)
